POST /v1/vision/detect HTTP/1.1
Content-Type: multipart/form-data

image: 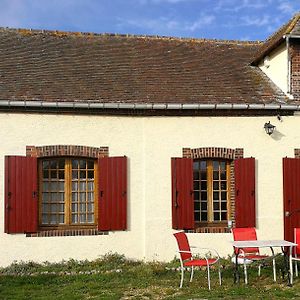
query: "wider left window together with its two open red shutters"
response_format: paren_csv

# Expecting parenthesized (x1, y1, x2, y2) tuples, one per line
(4, 152, 127, 236)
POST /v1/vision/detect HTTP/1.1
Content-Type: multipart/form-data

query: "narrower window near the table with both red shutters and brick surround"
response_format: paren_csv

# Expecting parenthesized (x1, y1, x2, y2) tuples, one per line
(171, 148, 256, 233)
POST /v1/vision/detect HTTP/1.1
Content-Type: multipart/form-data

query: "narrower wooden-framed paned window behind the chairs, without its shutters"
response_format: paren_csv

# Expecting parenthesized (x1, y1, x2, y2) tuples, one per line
(193, 160, 230, 226)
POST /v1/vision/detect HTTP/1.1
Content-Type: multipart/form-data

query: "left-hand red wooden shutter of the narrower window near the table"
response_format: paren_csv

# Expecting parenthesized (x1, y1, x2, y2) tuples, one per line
(171, 158, 195, 229)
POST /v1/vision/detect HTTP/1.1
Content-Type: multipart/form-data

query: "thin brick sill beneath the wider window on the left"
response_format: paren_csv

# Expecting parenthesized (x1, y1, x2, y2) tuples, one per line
(26, 229, 108, 237)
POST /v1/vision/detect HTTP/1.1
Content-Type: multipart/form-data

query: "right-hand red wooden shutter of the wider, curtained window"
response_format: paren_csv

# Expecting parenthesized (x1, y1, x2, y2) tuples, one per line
(98, 156, 127, 230)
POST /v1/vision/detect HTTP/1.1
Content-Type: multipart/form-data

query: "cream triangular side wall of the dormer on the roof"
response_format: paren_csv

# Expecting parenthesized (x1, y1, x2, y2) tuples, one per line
(258, 43, 288, 94)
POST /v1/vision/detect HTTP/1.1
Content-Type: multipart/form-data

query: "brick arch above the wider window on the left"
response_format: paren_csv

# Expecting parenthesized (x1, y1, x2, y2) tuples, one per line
(26, 145, 109, 158)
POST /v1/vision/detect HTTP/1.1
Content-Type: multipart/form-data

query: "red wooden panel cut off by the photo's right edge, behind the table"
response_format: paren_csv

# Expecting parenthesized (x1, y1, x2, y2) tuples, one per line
(283, 158, 300, 242)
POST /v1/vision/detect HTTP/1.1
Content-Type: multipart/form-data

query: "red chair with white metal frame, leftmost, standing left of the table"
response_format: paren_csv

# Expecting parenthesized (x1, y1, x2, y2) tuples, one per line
(174, 231, 222, 290)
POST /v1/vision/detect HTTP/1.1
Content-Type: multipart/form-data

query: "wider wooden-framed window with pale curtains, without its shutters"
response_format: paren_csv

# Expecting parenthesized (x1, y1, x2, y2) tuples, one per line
(39, 158, 97, 226)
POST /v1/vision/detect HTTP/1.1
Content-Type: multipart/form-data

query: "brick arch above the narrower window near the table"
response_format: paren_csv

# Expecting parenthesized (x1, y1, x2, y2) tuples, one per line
(182, 147, 244, 160)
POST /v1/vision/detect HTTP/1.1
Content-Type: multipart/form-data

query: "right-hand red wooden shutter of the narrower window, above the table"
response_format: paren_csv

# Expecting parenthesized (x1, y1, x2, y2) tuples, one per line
(234, 157, 256, 227)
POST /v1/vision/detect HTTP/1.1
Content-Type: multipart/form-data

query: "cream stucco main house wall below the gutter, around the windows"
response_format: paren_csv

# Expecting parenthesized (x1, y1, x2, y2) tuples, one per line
(0, 113, 300, 266)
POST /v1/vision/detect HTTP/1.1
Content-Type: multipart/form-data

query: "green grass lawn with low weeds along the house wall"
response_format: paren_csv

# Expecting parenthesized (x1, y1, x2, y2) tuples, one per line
(0, 255, 300, 300)
